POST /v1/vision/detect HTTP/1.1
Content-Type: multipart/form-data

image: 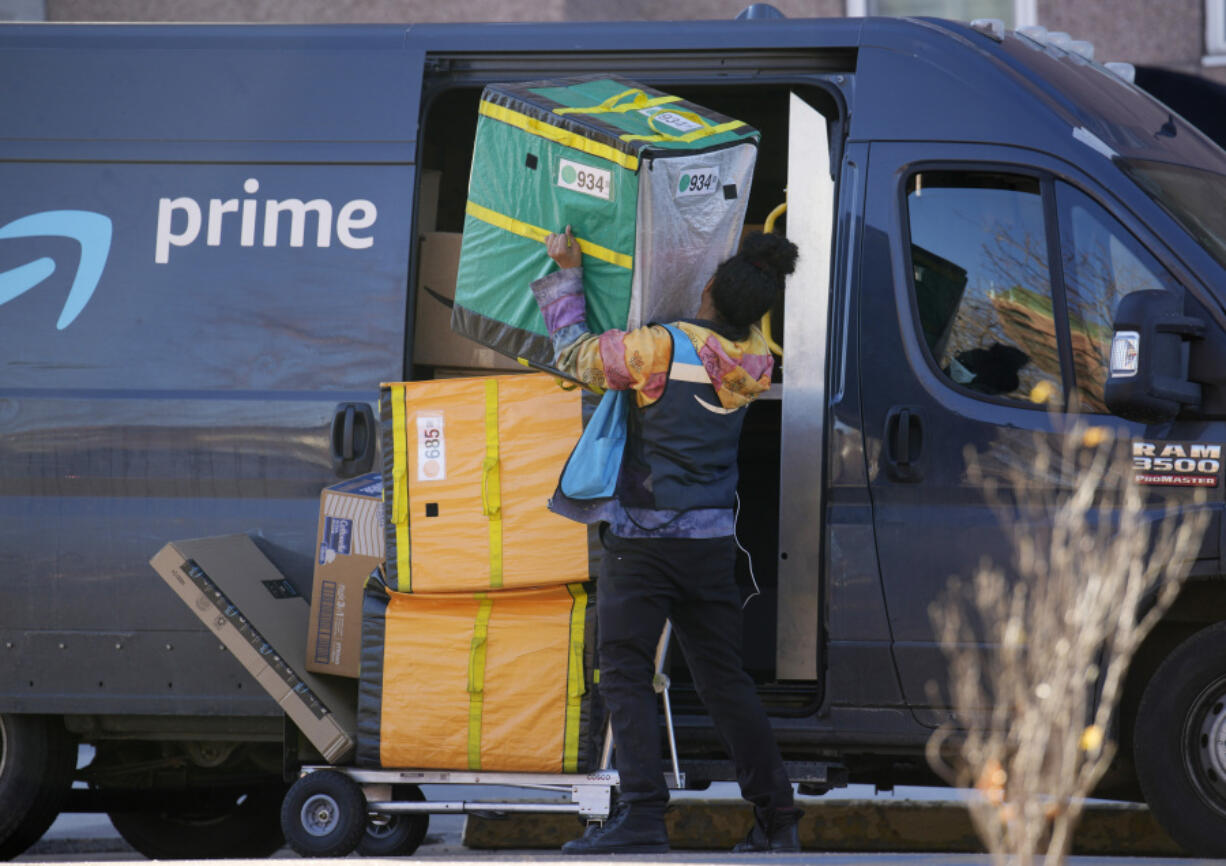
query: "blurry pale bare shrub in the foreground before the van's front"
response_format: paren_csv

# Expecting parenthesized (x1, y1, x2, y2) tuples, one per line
(928, 416, 1208, 866)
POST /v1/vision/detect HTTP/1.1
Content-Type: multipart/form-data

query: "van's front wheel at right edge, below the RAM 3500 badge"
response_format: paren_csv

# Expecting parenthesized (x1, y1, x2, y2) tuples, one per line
(1133, 622, 1226, 857)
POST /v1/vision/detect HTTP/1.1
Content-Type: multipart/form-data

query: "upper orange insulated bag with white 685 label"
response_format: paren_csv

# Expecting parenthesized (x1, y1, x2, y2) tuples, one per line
(379, 374, 588, 592)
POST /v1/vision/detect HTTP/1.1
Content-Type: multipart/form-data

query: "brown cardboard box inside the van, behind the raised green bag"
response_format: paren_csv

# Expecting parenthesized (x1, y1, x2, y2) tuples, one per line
(413, 232, 524, 370)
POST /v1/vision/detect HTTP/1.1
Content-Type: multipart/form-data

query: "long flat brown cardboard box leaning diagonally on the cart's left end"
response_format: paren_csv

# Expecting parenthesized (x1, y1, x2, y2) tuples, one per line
(150, 535, 357, 764)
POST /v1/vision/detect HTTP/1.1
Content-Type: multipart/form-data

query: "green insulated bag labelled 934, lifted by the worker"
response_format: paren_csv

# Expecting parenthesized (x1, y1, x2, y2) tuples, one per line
(451, 76, 758, 367)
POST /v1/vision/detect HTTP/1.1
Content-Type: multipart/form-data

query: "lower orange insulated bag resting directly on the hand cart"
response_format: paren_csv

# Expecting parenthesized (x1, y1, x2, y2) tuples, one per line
(357, 578, 601, 773)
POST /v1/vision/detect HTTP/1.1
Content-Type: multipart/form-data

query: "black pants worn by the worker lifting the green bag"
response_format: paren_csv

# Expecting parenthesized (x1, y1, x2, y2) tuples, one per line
(596, 532, 792, 808)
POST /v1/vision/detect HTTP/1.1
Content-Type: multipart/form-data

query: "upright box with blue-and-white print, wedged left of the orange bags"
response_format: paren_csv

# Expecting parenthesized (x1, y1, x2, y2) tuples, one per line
(307, 472, 384, 677)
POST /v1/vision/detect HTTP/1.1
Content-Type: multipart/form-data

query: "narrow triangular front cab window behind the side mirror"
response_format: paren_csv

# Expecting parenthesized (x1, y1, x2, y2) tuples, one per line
(1056, 183, 1181, 412)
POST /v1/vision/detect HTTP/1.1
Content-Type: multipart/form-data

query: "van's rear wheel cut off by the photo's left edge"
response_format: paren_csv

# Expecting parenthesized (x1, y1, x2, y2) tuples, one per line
(0, 715, 76, 860)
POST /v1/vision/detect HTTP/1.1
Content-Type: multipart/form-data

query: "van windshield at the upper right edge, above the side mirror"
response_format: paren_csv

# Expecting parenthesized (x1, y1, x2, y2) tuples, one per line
(1119, 159, 1226, 267)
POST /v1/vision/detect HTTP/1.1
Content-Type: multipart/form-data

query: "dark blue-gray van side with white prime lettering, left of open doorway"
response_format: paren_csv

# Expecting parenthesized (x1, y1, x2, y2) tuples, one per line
(0, 27, 422, 715)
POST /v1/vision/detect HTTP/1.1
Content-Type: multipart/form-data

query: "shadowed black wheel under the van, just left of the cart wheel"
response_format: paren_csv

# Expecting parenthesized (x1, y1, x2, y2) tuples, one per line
(108, 787, 284, 860)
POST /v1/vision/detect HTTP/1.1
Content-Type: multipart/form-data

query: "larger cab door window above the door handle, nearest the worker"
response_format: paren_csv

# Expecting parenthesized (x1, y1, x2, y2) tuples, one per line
(907, 172, 1062, 405)
